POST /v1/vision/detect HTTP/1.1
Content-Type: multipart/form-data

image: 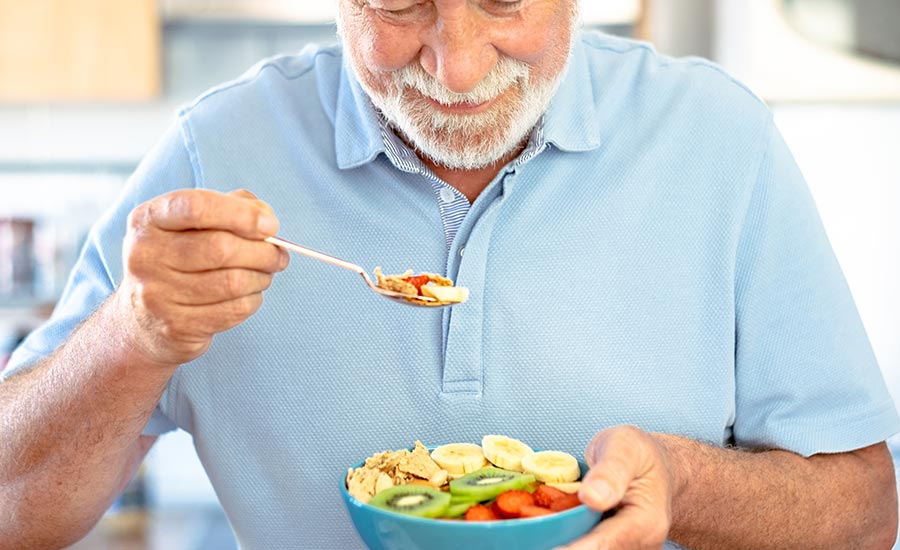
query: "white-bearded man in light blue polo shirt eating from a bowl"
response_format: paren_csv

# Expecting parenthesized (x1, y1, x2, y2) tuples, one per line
(0, 0, 898, 549)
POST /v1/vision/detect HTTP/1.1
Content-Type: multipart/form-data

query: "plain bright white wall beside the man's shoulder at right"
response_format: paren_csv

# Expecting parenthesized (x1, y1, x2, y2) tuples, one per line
(774, 103, 900, 396)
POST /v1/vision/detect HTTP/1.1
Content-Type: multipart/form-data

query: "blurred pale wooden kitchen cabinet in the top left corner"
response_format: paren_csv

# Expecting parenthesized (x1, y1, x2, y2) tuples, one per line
(0, 0, 160, 103)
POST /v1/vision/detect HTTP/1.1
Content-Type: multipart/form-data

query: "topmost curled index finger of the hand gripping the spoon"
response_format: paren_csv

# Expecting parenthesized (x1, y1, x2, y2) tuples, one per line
(131, 189, 278, 239)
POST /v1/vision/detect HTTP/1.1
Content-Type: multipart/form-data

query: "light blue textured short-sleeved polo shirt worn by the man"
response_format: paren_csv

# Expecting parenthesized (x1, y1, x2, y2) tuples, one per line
(11, 34, 900, 550)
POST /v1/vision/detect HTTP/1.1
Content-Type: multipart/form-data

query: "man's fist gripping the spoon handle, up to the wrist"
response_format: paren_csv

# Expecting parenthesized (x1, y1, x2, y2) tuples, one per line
(115, 189, 289, 365)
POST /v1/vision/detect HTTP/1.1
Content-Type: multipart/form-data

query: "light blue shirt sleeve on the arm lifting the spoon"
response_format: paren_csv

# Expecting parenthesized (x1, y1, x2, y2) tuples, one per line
(0, 121, 198, 435)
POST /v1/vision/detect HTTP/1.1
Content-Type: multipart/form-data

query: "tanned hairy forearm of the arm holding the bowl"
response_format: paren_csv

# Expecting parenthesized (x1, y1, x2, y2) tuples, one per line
(655, 435, 897, 549)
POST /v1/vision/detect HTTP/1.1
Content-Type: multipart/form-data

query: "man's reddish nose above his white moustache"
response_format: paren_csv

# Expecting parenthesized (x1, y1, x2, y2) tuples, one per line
(421, 7, 497, 93)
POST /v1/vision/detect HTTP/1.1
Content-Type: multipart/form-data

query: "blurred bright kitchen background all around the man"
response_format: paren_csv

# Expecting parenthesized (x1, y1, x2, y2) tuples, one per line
(0, 0, 900, 550)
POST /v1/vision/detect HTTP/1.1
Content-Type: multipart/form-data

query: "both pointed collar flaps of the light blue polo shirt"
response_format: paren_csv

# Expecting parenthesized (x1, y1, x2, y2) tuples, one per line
(334, 35, 600, 170)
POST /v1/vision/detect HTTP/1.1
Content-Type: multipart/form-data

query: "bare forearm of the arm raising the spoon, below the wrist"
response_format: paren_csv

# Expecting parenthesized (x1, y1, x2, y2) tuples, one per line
(0, 297, 175, 548)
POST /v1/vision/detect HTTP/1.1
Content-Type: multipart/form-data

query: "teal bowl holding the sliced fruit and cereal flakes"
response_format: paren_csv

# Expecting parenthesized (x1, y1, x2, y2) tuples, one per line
(341, 447, 601, 550)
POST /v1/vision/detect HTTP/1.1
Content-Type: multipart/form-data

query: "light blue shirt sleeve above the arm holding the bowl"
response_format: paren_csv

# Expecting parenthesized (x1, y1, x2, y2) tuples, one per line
(733, 119, 900, 456)
